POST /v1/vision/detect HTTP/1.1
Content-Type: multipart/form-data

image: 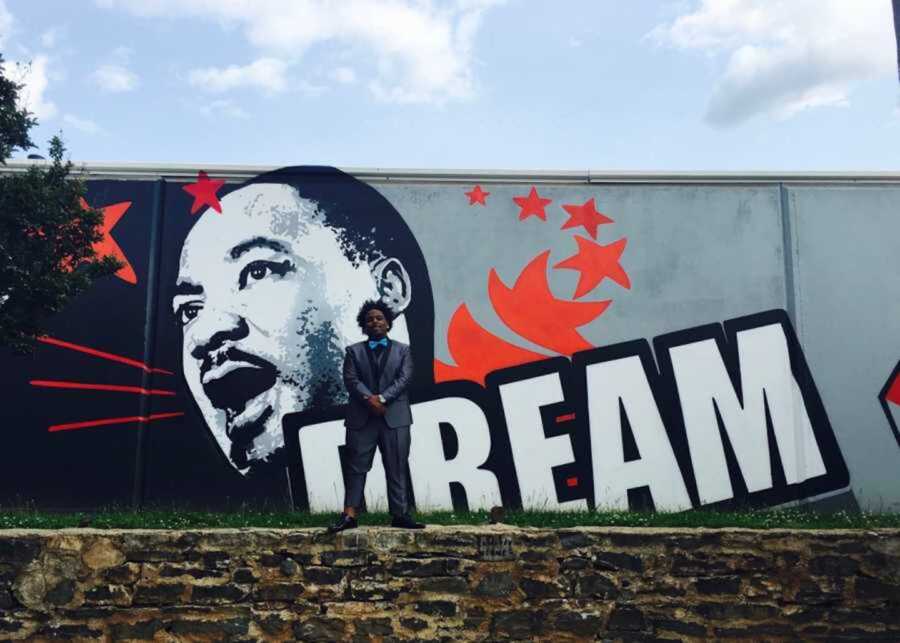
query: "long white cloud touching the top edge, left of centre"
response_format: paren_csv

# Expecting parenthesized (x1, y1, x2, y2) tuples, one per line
(96, 0, 503, 102)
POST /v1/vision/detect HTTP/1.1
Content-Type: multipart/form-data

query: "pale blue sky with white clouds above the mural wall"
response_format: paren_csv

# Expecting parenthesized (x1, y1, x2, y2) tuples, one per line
(0, 0, 900, 171)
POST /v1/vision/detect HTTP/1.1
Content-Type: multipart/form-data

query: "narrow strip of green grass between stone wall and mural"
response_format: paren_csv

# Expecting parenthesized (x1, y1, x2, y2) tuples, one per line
(0, 509, 900, 529)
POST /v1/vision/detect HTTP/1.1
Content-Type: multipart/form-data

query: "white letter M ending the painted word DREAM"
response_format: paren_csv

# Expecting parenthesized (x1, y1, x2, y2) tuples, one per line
(656, 311, 827, 505)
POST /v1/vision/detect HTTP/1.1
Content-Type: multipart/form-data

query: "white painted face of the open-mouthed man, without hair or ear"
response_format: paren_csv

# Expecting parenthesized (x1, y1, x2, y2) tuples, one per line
(172, 184, 377, 469)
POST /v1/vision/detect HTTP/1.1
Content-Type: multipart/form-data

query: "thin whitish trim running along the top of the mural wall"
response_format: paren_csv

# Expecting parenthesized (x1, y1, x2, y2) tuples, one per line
(0, 160, 900, 183)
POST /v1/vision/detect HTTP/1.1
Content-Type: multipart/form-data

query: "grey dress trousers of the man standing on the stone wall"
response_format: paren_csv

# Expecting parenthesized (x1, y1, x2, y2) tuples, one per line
(344, 417, 409, 516)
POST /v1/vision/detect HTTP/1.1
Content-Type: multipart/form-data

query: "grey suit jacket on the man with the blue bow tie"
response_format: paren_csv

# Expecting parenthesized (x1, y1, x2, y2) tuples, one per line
(344, 340, 413, 430)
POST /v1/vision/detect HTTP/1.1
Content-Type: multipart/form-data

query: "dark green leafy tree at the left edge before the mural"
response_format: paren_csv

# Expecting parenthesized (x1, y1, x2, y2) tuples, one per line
(0, 55, 121, 351)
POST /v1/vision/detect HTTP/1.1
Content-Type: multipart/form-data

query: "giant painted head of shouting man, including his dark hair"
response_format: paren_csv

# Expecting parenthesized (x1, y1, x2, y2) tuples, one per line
(172, 168, 433, 473)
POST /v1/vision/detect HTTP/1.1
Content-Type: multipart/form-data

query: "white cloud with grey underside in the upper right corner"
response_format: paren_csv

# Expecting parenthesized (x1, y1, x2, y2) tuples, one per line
(648, 0, 897, 126)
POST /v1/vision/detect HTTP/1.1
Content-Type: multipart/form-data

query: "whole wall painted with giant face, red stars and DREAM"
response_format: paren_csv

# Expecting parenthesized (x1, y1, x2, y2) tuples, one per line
(0, 168, 900, 511)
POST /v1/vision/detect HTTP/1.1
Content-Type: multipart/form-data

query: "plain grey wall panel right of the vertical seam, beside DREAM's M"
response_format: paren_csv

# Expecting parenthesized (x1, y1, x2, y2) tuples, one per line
(787, 186, 900, 511)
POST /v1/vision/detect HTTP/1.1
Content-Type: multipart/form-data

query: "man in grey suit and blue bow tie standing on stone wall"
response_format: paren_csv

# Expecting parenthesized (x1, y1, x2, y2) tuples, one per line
(329, 300, 425, 533)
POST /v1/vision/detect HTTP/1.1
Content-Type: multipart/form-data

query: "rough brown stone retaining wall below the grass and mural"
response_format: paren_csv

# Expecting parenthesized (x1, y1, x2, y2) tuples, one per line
(0, 526, 900, 641)
